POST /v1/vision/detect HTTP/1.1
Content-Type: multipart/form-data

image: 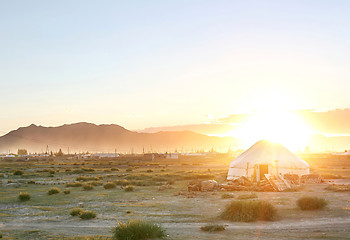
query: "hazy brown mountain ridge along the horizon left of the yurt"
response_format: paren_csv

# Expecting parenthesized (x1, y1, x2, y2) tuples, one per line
(0, 123, 238, 153)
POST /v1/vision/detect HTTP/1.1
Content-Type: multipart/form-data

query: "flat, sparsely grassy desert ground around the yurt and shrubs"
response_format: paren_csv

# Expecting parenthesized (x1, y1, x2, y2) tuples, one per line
(0, 155, 350, 240)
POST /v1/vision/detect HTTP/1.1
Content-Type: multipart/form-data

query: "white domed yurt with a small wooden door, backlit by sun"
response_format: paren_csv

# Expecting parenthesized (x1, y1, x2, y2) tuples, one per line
(227, 140, 309, 181)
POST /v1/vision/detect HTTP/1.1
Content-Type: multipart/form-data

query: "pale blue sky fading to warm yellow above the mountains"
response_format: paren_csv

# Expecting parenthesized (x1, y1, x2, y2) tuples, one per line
(0, 0, 350, 135)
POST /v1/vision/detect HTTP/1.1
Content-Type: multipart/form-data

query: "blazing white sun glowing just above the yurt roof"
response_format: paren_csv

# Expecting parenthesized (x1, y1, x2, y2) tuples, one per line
(231, 110, 311, 151)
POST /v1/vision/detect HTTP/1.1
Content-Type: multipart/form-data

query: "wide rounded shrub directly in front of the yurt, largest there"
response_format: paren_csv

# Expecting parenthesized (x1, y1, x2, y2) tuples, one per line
(221, 200, 277, 222)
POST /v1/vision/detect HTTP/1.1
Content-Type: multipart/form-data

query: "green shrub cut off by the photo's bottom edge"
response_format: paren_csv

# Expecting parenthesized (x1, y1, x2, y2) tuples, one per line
(113, 221, 166, 240)
